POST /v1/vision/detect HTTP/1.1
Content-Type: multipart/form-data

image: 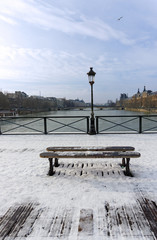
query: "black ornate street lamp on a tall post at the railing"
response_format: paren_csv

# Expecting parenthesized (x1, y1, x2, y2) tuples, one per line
(87, 67, 96, 135)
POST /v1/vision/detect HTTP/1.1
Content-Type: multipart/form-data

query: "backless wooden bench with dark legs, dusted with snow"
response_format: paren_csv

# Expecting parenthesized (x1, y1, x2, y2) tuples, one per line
(40, 146, 140, 176)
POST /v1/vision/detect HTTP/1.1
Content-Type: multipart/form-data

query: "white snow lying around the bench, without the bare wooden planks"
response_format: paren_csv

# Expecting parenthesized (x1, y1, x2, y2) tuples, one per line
(0, 134, 157, 240)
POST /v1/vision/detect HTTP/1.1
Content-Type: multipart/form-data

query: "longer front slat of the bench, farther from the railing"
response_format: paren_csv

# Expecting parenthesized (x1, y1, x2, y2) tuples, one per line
(40, 152, 141, 158)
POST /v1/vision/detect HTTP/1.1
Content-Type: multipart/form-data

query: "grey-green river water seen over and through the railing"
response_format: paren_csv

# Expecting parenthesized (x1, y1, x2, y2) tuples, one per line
(1, 108, 157, 134)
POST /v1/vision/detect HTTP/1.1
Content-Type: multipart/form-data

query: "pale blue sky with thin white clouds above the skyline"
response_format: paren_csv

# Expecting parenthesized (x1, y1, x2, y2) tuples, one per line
(0, 0, 157, 103)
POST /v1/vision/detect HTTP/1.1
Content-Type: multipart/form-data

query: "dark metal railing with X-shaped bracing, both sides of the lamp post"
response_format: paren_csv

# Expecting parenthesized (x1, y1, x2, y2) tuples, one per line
(0, 115, 157, 135)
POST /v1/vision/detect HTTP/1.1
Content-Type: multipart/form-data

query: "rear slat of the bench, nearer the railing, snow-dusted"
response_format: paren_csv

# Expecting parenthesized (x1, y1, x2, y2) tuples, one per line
(46, 146, 135, 152)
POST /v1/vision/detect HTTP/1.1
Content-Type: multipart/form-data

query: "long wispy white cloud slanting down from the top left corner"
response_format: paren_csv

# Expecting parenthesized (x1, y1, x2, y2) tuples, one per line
(0, 0, 134, 45)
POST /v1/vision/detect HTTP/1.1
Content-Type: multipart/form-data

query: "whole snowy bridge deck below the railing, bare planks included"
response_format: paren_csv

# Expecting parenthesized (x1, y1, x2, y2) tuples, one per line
(0, 134, 157, 240)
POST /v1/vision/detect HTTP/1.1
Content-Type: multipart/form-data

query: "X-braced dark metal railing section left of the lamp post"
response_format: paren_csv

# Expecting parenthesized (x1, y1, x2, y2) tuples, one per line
(0, 116, 89, 134)
